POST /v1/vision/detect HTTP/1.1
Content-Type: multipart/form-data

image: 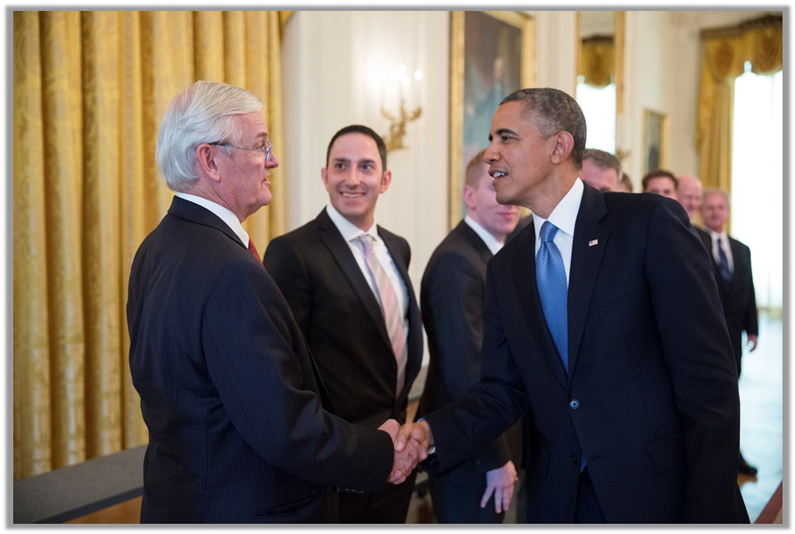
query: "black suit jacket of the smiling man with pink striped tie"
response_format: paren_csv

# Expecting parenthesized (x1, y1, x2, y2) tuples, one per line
(264, 209, 423, 427)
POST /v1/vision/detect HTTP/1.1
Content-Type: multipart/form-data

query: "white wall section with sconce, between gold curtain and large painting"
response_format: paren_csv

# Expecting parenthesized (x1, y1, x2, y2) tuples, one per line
(282, 11, 450, 291)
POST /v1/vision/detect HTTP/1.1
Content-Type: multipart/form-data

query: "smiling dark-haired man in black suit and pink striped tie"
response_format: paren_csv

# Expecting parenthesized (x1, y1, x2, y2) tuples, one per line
(264, 125, 423, 523)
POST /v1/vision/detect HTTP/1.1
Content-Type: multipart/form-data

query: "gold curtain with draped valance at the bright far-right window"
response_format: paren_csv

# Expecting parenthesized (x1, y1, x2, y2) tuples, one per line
(696, 15, 783, 195)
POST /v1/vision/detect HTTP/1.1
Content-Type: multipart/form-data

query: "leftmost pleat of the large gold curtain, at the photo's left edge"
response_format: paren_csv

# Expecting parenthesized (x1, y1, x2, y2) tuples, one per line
(14, 9, 52, 479)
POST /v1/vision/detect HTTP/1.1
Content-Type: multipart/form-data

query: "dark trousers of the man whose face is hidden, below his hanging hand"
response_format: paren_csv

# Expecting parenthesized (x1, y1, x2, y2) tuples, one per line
(428, 474, 505, 524)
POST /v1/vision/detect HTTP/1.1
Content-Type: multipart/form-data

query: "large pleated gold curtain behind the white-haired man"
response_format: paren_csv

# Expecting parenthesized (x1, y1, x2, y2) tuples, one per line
(13, 11, 286, 480)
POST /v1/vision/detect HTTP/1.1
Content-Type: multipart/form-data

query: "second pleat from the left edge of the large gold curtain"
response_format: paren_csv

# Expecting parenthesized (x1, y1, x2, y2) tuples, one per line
(41, 13, 86, 474)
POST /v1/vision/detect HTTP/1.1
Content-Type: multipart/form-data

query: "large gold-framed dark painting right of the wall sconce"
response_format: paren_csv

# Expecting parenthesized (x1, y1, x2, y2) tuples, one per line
(448, 11, 536, 228)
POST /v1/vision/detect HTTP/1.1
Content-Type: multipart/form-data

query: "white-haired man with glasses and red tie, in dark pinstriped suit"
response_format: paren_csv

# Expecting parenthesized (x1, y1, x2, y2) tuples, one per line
(127, 81, 422, 523)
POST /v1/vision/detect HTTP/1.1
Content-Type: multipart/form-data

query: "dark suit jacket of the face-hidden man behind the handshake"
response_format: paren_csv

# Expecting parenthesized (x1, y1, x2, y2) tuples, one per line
(417, 221, 521, 486)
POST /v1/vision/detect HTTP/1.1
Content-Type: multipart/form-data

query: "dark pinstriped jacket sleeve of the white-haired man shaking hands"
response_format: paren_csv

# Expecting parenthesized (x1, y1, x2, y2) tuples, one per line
(201, 261, 393, 491)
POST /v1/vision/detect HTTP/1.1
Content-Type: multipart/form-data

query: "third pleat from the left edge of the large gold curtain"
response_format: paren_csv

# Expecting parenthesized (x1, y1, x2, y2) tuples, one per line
(82, 11, 122, 458)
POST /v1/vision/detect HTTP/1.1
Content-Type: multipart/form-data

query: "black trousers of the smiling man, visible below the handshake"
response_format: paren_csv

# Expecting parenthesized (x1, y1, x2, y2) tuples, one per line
(337, 470, 417, 524)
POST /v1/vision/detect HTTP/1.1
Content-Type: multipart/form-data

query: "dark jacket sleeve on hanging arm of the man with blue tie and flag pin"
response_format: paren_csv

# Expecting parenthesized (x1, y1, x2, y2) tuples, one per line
(645, 200, 740, 523)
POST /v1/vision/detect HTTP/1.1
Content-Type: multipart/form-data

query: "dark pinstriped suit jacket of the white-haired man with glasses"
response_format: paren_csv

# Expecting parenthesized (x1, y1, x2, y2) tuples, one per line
(127, 197, 393, 523)
